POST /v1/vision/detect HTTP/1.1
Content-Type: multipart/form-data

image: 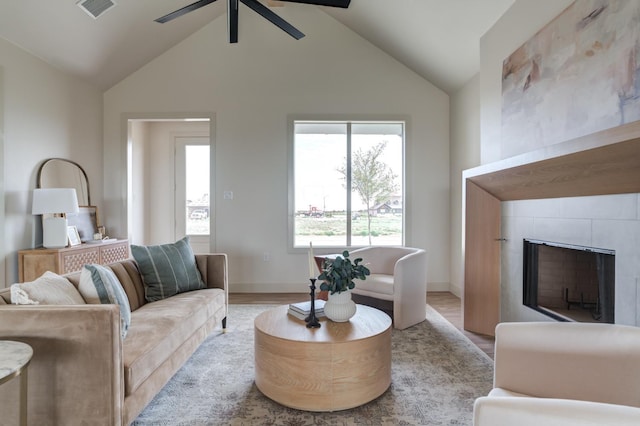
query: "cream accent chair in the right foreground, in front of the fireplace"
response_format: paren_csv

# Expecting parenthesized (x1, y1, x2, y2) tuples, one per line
(474, 322, 640, 426)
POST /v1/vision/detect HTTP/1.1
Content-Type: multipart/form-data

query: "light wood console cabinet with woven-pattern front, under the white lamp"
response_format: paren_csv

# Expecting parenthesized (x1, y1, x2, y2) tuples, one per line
(18, 240, 129, 282)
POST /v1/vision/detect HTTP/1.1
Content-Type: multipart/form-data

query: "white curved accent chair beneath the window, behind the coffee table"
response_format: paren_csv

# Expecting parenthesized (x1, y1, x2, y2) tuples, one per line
(349, 246, 427, 330)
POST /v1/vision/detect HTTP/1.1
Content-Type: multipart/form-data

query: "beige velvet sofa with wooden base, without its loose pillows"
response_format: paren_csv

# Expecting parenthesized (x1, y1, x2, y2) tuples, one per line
(0, 254, 228, 426)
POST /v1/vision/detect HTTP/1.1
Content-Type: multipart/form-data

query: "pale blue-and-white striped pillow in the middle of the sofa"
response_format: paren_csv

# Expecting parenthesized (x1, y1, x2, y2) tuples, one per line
(78, 264, 131, 339)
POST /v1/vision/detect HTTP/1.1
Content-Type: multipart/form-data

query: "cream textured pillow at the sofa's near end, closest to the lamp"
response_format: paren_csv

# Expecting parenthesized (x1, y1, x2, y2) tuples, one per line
(11, 271, 85, 305)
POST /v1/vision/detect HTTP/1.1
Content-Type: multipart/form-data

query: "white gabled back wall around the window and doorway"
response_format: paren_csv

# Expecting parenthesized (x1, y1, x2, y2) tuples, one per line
(104, 5, 450, 292)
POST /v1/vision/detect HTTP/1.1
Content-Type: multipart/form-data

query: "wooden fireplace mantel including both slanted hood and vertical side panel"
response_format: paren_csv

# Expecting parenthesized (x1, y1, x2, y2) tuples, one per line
(463, 121, 640, 335)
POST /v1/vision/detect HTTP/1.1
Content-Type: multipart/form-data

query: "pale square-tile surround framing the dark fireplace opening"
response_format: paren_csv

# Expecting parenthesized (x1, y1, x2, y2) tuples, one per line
(500, 194, 640, 326)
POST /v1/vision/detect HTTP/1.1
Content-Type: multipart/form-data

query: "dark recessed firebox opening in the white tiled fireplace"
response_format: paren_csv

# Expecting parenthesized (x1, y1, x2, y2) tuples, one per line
(523, 239, 615, 324)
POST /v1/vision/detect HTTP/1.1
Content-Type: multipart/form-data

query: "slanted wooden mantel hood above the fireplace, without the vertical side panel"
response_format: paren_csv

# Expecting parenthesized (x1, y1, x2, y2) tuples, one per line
(463, 121, 640, 201)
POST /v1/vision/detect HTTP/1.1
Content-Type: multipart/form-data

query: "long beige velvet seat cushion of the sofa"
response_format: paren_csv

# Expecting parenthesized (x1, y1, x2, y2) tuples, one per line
(122, 288, 225, 395)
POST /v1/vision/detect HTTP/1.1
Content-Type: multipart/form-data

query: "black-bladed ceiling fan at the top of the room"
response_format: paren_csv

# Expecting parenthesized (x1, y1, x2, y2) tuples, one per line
(155, 0, 351, 43)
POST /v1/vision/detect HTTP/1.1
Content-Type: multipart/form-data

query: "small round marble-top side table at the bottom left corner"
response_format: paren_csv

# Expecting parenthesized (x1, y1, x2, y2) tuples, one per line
(0, 340, 33, 426)
